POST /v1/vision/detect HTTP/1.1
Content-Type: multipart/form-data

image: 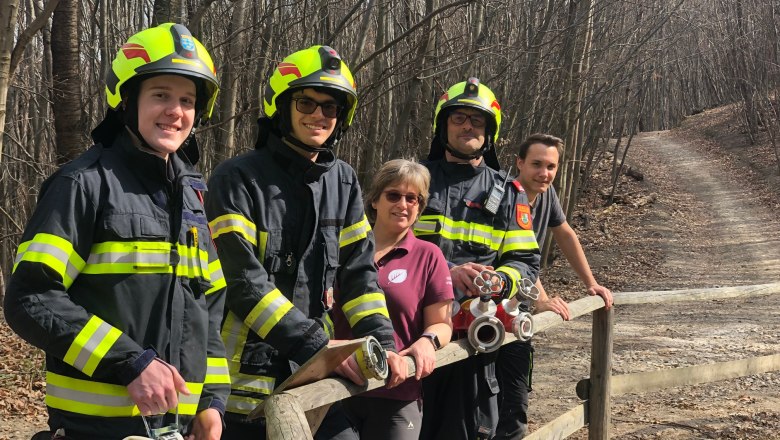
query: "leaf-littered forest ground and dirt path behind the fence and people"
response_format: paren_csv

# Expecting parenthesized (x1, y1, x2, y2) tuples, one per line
(0, 102, 780, 440)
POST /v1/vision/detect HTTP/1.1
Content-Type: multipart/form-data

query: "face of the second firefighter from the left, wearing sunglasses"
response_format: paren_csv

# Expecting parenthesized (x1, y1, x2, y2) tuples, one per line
(290, 89, 338, 147)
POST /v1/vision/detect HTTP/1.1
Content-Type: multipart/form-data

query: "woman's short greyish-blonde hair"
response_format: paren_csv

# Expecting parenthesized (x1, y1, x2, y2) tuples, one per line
(364, 159, 431, 223)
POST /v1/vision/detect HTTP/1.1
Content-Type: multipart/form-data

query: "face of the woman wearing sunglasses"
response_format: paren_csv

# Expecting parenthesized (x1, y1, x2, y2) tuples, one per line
(371, 182, 420, 235)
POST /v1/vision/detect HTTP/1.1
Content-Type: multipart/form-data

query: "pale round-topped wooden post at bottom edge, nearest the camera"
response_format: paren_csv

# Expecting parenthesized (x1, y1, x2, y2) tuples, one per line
(265, 393, 313, 440)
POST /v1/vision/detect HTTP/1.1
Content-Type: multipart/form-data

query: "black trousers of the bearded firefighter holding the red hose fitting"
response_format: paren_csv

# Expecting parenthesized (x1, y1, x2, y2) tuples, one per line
(420, 352, 498, 440)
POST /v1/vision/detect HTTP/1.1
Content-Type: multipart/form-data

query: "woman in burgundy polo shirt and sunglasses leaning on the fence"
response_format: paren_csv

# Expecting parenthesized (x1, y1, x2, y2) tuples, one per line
(334, 159, 453, 440)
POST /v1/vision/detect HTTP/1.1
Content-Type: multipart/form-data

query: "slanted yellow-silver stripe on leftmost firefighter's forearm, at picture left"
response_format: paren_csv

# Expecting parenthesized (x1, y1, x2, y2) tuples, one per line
(63, 316, 122, 376)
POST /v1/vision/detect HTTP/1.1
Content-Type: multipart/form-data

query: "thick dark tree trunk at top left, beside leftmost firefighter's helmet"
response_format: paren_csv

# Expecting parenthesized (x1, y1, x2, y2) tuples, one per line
(51, 0, 86, 164)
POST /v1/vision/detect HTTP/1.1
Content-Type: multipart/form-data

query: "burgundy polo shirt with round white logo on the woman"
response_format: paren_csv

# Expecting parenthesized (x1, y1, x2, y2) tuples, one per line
(333, 229, 453, 401)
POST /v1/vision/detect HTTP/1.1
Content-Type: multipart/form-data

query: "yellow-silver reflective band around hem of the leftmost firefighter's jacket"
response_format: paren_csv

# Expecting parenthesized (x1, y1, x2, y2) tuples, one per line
(46, 371, 203, 417)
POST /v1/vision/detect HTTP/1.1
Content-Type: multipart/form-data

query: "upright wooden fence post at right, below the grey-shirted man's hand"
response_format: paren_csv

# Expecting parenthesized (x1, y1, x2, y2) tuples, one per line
(588, 308, 614, 440)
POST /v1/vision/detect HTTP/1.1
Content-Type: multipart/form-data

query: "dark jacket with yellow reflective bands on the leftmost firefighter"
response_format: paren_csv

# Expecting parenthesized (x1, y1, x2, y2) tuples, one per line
(4, 131, 230, 439)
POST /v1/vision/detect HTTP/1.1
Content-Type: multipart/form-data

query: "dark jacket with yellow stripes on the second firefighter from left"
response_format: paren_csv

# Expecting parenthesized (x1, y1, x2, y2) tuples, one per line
(206, 133, 395, 420)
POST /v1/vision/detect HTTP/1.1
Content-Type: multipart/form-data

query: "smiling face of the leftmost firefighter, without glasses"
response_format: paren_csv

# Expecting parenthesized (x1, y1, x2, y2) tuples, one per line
(138, 75, 196, 159)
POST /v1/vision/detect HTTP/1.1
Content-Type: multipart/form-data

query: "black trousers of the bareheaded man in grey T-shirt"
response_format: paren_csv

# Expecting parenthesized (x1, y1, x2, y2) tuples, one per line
(495, 341, 534, 440)
